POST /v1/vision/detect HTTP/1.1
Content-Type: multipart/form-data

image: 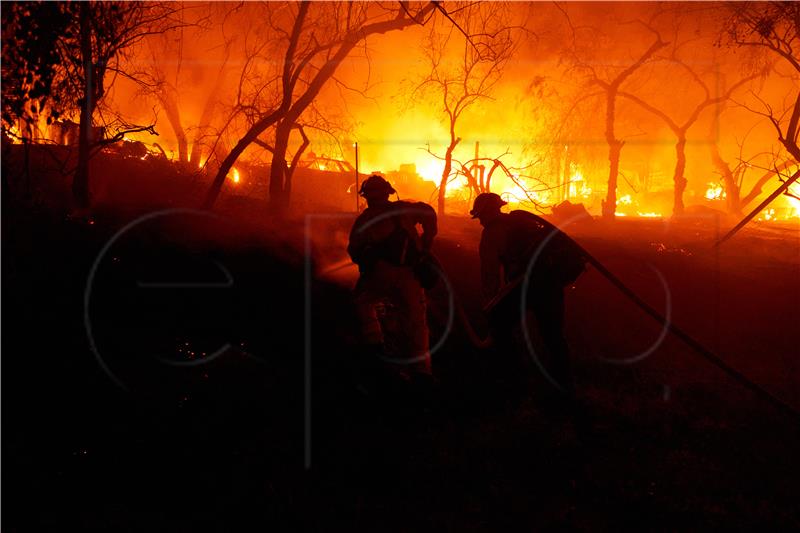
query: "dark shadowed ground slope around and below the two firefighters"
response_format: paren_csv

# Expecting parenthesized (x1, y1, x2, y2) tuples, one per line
(2, 201, 800, 532)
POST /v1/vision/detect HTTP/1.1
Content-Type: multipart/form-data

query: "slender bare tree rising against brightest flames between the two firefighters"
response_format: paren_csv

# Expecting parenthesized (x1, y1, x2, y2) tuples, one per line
(413, 4, 516, 215)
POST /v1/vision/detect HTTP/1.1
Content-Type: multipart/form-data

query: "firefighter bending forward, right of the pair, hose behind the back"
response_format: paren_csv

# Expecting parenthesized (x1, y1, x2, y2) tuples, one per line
(470, 193, 584, 397)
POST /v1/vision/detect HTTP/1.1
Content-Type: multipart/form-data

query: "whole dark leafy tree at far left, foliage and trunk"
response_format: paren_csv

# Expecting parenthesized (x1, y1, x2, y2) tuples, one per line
(3, 1, 182, 207)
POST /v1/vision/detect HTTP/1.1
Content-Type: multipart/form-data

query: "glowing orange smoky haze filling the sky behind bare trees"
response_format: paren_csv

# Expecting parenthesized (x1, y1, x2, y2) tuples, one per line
(14, 3, 797, 215)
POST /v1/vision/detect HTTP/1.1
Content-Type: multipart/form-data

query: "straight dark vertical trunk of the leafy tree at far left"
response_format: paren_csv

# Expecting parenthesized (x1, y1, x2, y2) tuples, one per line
(72, 2, 94, 208)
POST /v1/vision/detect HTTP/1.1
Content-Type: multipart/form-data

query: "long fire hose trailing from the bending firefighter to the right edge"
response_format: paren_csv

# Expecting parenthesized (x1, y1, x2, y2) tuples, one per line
(444, 217, 800, 419)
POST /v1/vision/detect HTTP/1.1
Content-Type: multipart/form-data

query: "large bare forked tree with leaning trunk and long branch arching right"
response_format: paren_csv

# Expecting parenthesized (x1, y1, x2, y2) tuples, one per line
(204, 1, 494, 209)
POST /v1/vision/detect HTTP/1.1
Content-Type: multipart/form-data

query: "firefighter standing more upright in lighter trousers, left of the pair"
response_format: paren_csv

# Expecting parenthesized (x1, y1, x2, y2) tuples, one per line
(347, 175, 437, 378)
